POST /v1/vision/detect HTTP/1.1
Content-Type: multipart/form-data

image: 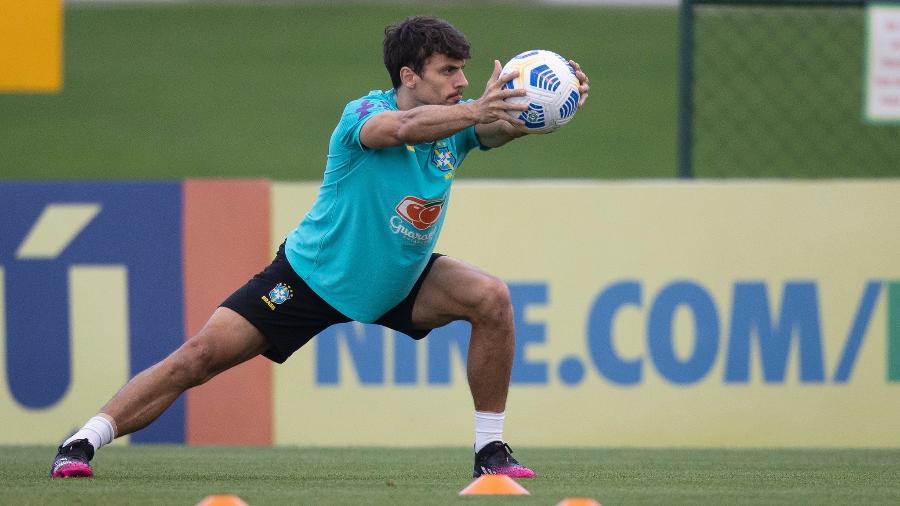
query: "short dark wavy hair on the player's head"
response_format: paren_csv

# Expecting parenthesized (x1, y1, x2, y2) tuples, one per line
(384, 16, 470, 88)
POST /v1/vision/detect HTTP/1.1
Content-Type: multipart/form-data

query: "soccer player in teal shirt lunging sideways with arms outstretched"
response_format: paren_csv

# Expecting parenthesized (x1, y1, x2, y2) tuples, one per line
(50, 17, 589, 478)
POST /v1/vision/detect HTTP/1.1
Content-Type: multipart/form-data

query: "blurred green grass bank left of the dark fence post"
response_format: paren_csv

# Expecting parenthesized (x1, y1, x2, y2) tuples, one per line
(0, 2, 677, 180)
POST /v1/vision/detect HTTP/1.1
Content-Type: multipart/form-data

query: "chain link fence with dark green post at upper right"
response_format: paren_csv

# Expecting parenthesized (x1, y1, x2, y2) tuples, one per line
(680, 0, 900, 178)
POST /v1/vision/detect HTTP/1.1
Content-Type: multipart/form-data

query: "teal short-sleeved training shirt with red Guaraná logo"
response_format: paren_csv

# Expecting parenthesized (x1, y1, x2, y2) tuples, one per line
(285, 90, 480, 323)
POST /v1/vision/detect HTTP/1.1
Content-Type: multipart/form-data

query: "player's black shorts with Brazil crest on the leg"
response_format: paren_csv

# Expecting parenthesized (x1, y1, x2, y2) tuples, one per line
(221, 243, 443, 364)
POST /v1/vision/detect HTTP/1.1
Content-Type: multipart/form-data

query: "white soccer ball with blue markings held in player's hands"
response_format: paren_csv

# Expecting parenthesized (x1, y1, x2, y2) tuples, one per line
(500, 49, 581, 134)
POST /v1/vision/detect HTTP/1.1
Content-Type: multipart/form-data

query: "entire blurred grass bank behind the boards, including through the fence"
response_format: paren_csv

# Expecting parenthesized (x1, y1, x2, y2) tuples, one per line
(0, 0, 900, 181)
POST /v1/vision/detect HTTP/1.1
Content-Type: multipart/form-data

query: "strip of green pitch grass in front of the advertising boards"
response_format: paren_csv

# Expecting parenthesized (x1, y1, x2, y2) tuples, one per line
(7, 446, 900, 506)
